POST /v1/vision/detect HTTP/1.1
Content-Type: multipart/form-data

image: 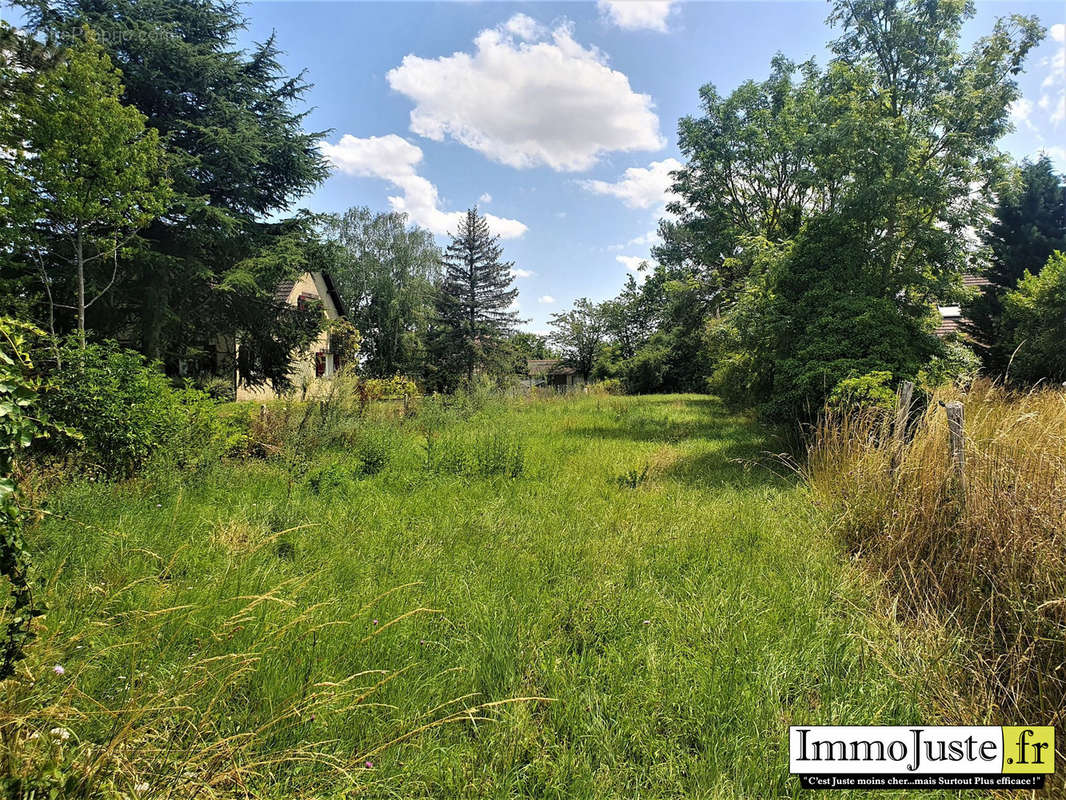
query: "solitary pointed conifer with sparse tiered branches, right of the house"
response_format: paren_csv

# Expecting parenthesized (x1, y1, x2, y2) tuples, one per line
(434, 208, 520, 387)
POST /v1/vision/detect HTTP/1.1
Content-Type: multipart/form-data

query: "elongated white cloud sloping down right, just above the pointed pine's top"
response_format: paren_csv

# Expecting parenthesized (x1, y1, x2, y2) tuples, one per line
(319, 133, 528, 239)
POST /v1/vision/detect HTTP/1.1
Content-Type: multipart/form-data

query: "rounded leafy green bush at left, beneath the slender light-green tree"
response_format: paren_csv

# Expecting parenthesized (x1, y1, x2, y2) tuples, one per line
(41, 339, 215, 477)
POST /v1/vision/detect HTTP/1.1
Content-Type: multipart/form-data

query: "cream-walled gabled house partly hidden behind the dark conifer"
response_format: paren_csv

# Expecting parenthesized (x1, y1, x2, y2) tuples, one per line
(234, 272, 344, 400)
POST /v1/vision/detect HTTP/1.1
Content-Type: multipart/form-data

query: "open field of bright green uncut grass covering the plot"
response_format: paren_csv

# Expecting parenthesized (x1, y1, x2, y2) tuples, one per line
(16, 396, 967, 798)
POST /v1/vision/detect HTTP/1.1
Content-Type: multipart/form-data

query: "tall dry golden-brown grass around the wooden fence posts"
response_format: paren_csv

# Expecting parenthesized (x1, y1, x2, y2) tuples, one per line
(806, 382, 1066, 763)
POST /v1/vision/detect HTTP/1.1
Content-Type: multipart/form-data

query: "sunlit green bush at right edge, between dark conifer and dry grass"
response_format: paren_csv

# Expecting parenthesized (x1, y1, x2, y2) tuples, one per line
(1003, 252, 1066, 383)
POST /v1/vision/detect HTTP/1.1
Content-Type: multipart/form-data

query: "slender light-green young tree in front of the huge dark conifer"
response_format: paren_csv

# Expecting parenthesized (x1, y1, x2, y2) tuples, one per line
(15, 28, 171, 348)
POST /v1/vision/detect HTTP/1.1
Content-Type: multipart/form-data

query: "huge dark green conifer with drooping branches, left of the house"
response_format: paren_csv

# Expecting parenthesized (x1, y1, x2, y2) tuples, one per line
(18, 0, 328, 368)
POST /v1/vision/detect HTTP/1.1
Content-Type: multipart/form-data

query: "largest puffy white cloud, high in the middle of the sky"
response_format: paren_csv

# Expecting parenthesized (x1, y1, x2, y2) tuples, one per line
(386, 17, 665, 172)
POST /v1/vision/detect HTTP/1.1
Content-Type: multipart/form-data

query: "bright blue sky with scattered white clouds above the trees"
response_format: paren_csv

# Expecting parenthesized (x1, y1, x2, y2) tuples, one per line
(12, 0, 1066, 332)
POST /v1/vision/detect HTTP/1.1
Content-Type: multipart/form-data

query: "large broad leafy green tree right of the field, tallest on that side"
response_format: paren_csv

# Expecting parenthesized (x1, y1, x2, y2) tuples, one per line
(657, 0, 1041, 419)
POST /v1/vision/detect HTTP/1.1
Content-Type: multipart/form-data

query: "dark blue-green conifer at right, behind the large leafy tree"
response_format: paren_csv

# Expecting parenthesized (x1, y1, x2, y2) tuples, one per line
(964, 156, 1066, 372)
